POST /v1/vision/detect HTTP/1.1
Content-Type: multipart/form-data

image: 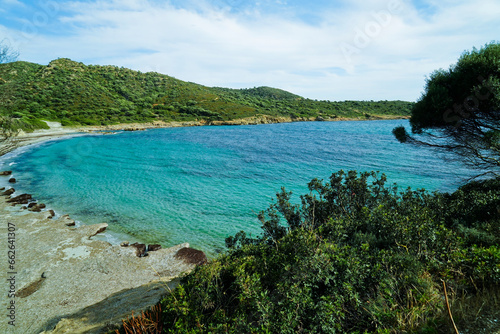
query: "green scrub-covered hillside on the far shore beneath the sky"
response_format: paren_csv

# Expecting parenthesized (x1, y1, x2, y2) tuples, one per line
(0, 58, 412, 130)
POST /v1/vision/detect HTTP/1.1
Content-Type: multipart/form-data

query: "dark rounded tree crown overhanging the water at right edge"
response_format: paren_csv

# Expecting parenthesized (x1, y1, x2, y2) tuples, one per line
(393, 42, 500, 176)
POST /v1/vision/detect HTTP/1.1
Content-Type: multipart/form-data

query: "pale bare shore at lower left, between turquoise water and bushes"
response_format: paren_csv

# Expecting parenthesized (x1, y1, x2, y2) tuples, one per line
(0, 197, 201, 334)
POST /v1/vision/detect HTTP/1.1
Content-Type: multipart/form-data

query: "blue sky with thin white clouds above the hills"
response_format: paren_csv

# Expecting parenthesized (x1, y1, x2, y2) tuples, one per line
(0, 0, 500, 101)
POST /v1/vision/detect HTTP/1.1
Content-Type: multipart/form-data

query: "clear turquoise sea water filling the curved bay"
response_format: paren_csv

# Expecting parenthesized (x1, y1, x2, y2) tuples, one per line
(0, 120, 471, 255)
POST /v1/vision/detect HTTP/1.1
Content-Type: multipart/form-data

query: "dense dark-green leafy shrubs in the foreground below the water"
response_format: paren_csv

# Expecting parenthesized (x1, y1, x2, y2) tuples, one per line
(162, 171, 500, 333)
